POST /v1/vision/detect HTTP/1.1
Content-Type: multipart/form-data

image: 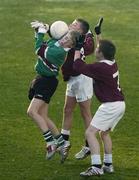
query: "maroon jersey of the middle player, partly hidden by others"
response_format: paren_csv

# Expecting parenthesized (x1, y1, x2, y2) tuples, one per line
(61, 33, 94, 81)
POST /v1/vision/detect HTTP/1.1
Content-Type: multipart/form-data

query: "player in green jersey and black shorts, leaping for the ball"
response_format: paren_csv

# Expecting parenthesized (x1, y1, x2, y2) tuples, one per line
(27, 21, 79, 162)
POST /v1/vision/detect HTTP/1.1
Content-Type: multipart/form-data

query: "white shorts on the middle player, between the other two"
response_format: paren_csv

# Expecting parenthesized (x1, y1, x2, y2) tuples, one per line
(66, 74, 93, 102)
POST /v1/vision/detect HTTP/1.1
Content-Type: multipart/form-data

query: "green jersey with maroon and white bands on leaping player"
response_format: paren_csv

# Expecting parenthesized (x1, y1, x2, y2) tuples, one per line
(35, 33, 67, 76)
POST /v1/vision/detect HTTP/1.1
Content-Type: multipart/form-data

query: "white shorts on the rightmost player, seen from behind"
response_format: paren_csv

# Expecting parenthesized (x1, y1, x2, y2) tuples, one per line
(91, 101, 125, 131)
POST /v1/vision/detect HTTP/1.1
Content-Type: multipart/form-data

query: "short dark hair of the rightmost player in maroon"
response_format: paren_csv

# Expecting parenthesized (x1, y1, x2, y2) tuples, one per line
(99, 39, 116, 60)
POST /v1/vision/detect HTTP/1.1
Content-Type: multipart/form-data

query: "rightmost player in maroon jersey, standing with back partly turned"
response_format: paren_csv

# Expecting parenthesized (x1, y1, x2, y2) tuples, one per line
(73, 27, 125, 176)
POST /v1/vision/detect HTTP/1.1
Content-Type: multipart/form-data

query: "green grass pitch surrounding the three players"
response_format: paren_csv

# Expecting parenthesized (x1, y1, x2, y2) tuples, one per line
(0, 0, 139, 180)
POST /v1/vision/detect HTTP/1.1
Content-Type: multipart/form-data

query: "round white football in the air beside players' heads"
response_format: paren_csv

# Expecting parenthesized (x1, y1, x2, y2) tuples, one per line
(50, 21, 69, 39)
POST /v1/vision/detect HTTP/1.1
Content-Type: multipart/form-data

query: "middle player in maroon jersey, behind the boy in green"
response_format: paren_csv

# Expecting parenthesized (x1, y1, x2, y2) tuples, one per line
(61, 19, 94, 159)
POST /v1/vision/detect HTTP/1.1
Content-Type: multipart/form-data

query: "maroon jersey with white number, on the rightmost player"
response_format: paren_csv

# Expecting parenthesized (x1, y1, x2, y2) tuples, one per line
(73, 59, 124, 103)
